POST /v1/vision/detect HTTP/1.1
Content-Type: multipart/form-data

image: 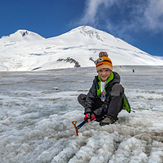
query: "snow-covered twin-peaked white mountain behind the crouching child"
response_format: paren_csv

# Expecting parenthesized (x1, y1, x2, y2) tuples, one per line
(0, 26, 163, 71)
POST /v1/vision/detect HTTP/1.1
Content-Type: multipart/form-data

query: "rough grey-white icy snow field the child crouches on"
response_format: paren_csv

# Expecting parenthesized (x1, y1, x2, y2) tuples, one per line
(0, 66, 163, 163)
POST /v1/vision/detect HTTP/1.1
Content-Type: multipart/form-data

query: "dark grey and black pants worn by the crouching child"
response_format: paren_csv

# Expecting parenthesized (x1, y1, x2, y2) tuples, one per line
(78, 84, 124, 121)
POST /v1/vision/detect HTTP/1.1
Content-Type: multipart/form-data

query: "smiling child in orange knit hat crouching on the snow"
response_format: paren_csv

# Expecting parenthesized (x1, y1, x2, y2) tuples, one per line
(78, 52, 131, 126)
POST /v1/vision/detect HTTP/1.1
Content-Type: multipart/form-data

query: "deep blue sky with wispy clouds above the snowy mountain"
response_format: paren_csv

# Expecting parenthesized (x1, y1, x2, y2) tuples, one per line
(0, 0, 163, 56)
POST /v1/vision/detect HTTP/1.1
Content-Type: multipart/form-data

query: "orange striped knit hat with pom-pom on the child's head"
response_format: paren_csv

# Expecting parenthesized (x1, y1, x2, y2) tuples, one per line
(95, 52, 113, 71)
